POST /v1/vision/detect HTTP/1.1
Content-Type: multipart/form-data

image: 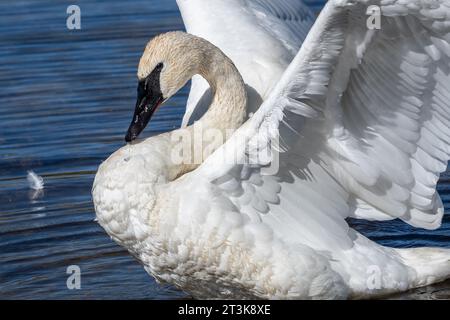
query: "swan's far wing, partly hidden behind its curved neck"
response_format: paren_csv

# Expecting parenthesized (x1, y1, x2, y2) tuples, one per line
(177, 0, 315, 124)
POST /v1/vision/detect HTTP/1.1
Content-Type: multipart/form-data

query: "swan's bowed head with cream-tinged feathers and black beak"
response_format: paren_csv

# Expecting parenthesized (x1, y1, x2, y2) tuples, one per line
(125, 31, 206, 142)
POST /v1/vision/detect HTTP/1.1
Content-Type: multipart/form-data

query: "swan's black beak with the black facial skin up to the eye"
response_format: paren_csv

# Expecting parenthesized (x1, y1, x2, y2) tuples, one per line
(125, 63, 164, 142)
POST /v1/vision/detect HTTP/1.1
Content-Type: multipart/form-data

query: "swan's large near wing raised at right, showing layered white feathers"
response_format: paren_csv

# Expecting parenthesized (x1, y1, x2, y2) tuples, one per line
(191, 0, 450, 248)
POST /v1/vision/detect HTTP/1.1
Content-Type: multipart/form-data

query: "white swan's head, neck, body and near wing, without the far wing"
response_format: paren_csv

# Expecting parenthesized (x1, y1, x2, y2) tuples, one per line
(93, 0, 450, 299)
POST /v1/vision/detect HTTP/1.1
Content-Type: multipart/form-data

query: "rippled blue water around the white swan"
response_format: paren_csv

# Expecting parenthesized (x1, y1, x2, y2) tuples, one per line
(0, 0, 450, 299)
